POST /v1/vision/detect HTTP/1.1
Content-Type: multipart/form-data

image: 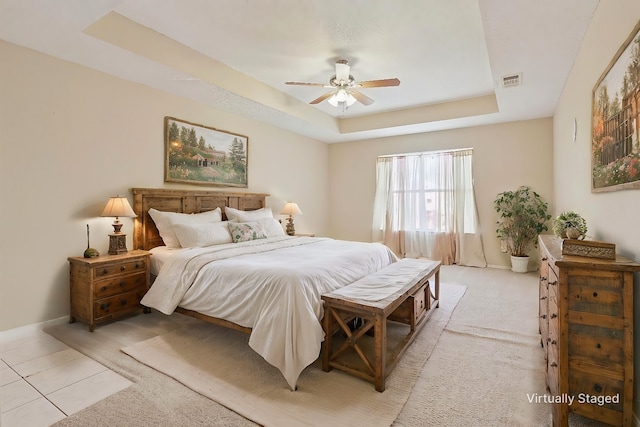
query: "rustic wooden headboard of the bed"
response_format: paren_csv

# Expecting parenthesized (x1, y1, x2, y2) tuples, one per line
(131, 188, 269, 250)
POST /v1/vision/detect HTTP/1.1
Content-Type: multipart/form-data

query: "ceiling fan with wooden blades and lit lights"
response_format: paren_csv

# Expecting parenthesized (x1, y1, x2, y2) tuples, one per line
(285, 59, 400, 109)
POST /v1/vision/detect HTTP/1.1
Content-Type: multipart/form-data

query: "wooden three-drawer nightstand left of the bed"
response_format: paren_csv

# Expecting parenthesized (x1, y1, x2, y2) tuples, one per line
(68, 250, 151, 332)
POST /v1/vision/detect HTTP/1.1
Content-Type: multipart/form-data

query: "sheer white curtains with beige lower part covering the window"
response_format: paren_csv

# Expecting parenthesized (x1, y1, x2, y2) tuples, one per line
(373, 149, 487, 267)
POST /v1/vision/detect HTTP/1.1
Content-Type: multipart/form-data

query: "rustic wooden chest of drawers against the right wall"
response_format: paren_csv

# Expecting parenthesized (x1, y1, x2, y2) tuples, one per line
(539, 235, 640, 426)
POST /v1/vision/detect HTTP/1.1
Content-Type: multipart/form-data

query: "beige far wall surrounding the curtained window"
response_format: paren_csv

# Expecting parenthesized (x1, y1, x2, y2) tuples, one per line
(329, 119, 553, 267)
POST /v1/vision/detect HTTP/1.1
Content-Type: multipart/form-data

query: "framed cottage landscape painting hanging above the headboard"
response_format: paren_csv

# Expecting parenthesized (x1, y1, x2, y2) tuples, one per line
(164, 117, 249, 187)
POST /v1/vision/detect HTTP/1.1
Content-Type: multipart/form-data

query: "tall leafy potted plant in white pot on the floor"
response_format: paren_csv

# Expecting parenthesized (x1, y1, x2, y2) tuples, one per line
(493, 186, 551, 273)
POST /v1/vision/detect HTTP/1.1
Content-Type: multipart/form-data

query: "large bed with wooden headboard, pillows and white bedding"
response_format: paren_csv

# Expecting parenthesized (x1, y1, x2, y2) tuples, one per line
(132, 188, 397, 390)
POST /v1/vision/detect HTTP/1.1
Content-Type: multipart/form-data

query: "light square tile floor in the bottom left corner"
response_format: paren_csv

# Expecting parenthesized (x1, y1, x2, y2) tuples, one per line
(0, 328, 131, 427)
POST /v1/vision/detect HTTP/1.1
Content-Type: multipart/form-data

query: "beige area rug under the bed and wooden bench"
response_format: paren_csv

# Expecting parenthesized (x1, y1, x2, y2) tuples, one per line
(122, 283, 466, 426)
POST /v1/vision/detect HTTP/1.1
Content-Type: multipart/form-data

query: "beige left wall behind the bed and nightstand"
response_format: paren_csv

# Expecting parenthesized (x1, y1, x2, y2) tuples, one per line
(0, 41, 329, 331)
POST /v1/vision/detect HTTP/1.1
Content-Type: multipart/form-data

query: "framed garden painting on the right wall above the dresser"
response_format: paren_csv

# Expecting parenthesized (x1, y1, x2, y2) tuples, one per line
(591, 22, 640, 192)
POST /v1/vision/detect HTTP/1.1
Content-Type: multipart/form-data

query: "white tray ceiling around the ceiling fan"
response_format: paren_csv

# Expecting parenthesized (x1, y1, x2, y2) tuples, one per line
(0, 0, 598, 143)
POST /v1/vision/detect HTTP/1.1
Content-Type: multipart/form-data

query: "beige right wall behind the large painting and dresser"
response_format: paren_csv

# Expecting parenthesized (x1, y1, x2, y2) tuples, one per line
(553, 0, 640, 412)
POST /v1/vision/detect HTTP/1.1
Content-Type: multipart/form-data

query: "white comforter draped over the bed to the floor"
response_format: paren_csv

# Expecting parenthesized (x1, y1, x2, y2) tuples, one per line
(142, 236, 396, 389)
